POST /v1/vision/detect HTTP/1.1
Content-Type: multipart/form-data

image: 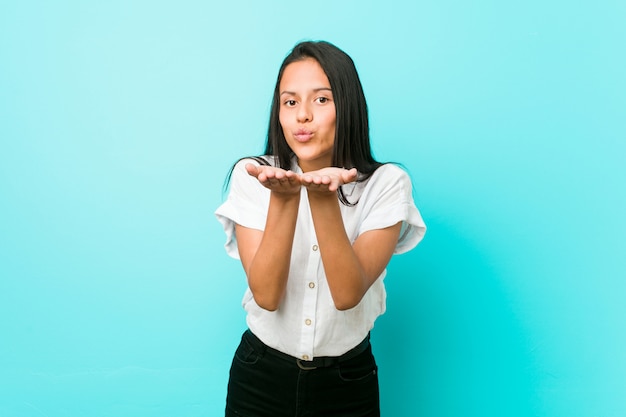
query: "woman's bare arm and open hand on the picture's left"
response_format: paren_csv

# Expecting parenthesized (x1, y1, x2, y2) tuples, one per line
(235, 164, 301, 311)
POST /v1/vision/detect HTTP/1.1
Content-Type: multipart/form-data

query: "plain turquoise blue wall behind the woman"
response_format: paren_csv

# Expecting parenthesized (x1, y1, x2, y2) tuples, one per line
(0, 0, 626, 417)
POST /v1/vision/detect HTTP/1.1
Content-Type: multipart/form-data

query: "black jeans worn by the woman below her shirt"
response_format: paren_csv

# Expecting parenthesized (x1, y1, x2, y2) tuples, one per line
(226, 330, 380, 417)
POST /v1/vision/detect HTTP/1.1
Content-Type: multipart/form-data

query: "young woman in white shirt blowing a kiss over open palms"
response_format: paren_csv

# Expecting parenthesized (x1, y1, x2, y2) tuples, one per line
(216, 42, 426, 417)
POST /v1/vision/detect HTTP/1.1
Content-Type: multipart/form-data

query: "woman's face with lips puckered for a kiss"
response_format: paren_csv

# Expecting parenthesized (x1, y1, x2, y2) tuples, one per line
(278, 58, 337, 172)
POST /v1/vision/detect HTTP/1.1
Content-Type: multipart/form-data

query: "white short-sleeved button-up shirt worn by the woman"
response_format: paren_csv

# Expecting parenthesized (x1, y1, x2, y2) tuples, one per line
(215, 158, 426, 360)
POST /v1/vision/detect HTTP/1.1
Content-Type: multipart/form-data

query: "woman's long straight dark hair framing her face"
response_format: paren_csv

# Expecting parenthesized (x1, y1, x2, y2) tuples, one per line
(227, 41, 382, 205)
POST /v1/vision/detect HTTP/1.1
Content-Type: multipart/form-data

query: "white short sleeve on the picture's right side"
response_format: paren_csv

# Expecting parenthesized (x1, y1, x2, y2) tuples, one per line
(358, 164, 426, 254)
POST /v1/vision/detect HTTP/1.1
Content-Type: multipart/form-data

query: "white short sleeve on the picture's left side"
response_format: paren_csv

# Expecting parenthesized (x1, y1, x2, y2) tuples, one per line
(215, 159, 269, 259)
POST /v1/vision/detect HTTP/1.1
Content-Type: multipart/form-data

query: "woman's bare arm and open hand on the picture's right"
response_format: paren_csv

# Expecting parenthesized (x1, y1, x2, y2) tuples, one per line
(302, 168, 401, 310)
